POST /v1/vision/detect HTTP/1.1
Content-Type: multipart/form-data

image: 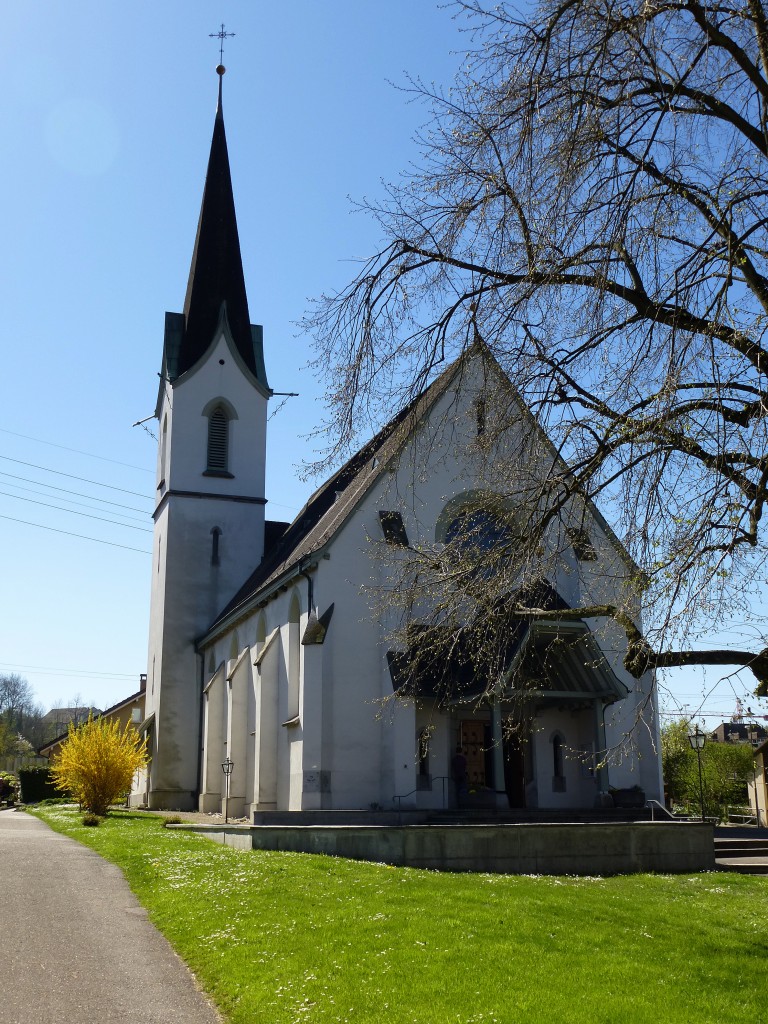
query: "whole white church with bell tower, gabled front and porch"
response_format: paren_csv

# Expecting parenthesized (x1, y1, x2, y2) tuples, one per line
(131, 74, 662, 818)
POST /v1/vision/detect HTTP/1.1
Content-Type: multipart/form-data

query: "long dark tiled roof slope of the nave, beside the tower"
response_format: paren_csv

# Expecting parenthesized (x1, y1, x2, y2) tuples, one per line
(204, 350, 471, 633)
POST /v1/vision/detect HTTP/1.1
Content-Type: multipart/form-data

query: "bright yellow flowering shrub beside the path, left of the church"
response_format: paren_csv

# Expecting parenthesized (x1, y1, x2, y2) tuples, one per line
(51, 717, 148, 815)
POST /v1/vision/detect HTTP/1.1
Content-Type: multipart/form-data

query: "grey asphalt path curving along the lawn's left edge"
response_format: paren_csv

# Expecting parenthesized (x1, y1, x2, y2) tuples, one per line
(0, 810, 221, 1024)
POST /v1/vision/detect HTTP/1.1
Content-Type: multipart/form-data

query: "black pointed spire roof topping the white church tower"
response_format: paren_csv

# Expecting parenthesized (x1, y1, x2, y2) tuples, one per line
(176, 65, 257, 376)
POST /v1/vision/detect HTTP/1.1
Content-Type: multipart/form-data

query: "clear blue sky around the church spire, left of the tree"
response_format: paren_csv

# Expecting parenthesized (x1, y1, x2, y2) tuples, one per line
(0, 0, 756, 729)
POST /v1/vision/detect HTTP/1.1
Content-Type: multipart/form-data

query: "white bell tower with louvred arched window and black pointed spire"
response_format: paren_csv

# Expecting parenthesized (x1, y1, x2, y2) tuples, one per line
(137, 65, 271, 809)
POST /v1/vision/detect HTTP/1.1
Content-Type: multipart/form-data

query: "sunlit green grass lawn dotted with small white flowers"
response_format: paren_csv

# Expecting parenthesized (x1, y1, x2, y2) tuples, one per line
(31, 808, 768, 1024)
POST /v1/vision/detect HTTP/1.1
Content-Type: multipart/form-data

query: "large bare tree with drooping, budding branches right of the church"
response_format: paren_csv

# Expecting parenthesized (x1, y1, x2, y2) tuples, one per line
(307, 0, 768, 693)
